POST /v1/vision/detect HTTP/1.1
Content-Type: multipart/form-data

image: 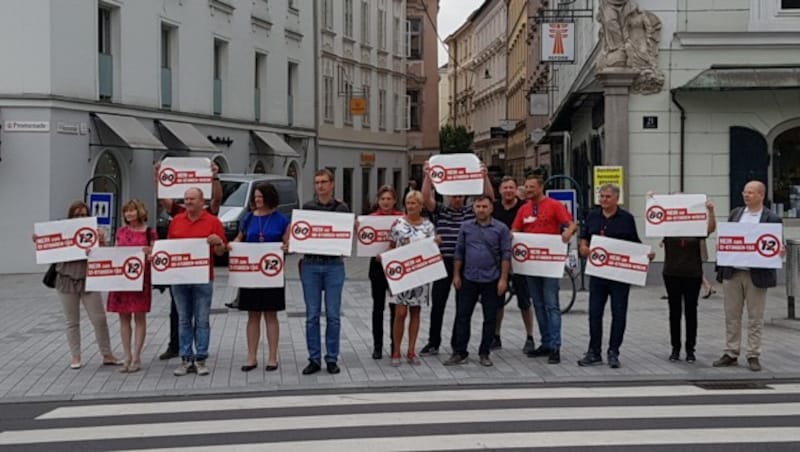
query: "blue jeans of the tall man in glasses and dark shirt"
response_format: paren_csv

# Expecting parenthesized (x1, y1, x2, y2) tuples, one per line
(300, 259, 344, 364)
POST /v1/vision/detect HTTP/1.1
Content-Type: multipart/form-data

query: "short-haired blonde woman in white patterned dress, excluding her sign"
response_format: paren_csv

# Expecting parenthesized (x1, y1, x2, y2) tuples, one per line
(381, 190, 436, 367)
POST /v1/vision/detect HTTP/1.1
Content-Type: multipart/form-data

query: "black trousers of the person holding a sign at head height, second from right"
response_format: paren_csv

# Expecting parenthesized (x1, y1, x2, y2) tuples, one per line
(663, 275, 703, 352)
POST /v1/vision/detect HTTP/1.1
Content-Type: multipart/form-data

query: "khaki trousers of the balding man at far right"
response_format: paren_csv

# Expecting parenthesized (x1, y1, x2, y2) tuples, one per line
(722, 270, 767, 358)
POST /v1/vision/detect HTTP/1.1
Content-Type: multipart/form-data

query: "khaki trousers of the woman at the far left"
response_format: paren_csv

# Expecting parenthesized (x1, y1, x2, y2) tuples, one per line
(58, 292, 111, 357)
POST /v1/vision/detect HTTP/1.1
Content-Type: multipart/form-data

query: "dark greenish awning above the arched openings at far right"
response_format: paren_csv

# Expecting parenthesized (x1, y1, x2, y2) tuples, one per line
(676, 65, 800, 91)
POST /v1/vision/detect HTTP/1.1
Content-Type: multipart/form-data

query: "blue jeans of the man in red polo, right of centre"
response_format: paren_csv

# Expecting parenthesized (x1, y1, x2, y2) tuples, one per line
(525, 276, 561, 350)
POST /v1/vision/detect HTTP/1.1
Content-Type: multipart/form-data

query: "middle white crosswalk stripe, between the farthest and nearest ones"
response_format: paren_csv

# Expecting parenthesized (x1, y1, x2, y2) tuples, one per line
(0, 402, 800, 447)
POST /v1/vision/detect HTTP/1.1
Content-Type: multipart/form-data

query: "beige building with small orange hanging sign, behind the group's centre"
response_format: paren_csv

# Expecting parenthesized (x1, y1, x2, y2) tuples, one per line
(313, 0, 410, 212)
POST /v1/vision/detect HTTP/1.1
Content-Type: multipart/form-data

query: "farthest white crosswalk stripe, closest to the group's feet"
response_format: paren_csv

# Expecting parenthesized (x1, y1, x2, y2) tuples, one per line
(36, 384, 800, 420)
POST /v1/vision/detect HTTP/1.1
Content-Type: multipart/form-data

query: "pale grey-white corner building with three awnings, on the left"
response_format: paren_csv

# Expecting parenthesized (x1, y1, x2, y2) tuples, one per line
(0, 0, 317, 273)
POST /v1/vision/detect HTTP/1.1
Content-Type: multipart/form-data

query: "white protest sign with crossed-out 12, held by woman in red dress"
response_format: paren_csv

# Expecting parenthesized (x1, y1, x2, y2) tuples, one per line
(86, 246, 146, 292)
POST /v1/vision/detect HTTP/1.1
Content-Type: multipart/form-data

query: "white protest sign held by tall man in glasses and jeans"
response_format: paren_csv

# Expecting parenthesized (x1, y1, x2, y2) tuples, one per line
(289, 209, 355, 256)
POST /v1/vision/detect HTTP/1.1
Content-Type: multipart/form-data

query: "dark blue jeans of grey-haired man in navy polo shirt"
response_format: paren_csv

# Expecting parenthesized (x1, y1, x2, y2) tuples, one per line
(589, 276, 631, 356)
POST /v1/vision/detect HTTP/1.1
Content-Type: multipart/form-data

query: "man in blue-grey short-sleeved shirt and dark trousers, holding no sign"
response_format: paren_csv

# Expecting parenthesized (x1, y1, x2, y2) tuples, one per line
(444, 195, 511, 367)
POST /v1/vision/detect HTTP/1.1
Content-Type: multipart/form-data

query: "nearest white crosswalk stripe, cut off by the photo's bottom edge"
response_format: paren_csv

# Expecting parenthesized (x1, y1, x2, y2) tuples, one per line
(125, 427, 800, 452)
